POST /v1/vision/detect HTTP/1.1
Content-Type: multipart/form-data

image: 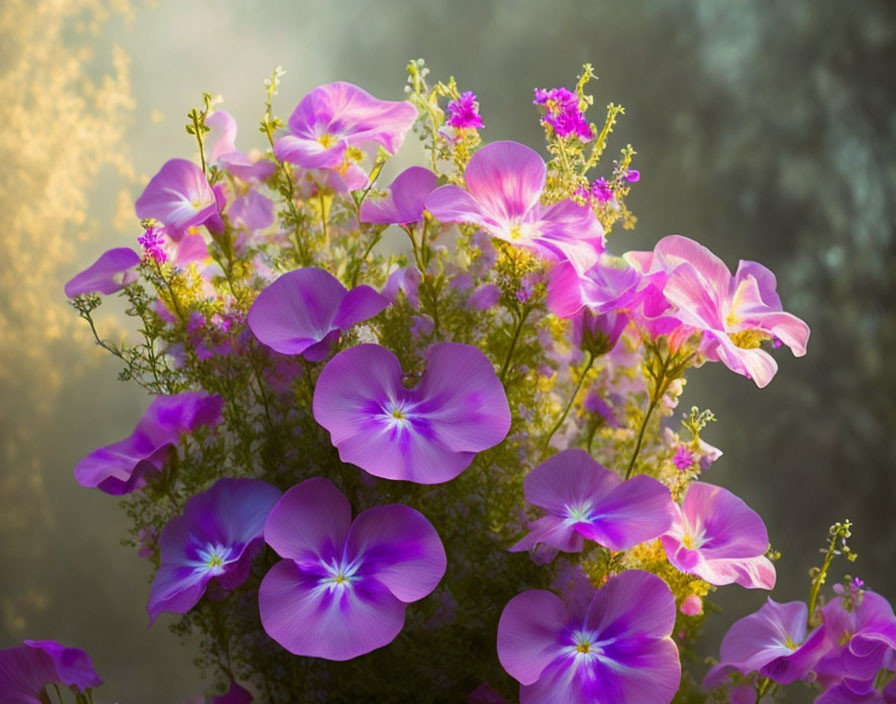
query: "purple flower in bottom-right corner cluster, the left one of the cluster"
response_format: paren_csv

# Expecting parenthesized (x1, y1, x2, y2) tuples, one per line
(703, 599, 824, 687)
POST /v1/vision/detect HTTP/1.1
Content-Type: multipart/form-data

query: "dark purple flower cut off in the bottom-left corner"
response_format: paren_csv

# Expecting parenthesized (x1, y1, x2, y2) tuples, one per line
(0, 640, 103, 704)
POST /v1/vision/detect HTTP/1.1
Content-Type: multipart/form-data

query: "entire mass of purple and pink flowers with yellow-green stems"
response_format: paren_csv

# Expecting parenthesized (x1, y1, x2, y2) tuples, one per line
(0, 61, 896, 704)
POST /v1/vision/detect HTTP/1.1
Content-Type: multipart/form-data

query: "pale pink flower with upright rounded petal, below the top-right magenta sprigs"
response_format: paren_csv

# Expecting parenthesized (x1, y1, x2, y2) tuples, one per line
(426, 142, 604, 272)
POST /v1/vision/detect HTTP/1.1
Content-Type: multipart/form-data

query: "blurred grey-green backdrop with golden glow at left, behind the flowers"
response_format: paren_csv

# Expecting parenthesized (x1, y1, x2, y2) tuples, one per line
(0, 0, 896, 704)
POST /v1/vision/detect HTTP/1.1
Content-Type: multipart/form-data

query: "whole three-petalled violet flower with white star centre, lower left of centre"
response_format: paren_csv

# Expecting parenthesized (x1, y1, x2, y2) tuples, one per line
(258, 477, 447, 660)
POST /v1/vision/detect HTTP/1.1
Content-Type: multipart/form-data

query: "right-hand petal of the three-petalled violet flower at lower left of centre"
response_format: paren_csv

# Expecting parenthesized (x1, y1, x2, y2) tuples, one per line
(346, 504, 447, 603)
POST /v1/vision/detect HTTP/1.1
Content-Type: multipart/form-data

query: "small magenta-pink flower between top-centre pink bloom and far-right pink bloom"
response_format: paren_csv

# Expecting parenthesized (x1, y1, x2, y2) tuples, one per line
(548, 252, 643, 318)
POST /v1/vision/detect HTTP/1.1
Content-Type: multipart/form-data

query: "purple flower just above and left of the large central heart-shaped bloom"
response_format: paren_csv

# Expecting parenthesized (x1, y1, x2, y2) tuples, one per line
(248, 268, 389, 362)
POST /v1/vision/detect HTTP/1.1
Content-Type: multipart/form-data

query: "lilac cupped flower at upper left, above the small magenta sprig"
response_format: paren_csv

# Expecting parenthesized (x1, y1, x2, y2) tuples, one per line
(135, 159, 218, 234)
